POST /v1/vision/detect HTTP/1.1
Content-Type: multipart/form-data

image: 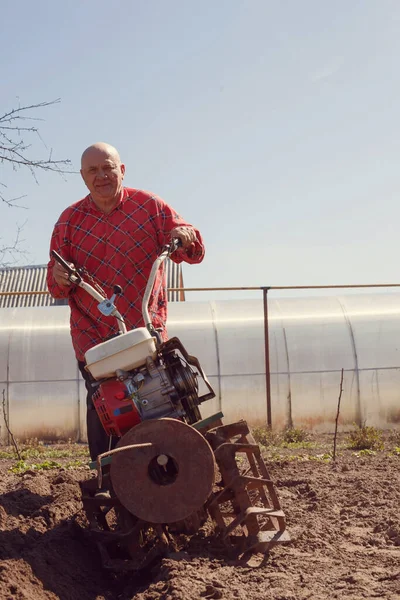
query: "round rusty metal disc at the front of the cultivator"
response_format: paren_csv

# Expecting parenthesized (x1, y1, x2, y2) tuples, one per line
(111, 418, 215, 523)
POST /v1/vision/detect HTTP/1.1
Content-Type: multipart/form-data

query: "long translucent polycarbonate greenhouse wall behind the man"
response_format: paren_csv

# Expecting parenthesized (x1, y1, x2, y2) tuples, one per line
(0, 293, 400, 438)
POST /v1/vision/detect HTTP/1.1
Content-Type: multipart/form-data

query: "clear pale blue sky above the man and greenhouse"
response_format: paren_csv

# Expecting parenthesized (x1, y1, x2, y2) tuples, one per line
(0, 0, 400, 300)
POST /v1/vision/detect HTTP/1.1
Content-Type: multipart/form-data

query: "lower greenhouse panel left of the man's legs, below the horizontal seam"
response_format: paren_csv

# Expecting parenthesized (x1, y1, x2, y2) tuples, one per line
(9, 380, 79, 440)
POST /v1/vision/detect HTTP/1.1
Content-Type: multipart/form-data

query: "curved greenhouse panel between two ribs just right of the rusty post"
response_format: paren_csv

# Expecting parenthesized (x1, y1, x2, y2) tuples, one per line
(272, 297, 360, 430)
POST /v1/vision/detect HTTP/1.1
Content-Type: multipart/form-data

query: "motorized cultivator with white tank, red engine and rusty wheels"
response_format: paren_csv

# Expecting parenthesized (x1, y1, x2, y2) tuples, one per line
(53, 240, 290, 570)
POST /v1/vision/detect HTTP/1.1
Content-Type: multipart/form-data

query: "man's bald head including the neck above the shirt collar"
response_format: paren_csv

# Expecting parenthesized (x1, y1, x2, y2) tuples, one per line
(81, 142, 125, 212)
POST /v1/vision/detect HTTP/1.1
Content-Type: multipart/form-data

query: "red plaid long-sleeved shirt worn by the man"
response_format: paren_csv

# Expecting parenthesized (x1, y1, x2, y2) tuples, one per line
(47, 188, 204, 360)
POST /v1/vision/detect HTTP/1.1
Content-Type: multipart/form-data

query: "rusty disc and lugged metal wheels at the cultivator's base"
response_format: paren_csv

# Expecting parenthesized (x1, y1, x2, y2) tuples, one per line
(81, 415, 290, 570)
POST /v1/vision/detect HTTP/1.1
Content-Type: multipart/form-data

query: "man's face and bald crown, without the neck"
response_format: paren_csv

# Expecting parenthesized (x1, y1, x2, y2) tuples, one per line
(81, 148, 125, 204)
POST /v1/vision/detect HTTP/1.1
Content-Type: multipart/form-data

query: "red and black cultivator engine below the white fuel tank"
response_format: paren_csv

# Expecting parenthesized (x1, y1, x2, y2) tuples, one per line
(93, 338, 215, 437)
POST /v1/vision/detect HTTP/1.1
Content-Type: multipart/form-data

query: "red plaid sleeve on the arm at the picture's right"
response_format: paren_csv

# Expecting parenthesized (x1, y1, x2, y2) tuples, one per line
(154, 196, 205, 264)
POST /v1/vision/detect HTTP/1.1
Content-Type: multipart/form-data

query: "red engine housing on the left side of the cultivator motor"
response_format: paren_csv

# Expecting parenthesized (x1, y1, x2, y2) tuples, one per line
(93, 379, 142, 437)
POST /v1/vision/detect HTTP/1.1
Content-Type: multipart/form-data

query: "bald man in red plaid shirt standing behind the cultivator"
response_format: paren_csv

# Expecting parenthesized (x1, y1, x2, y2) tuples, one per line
(47, 143, 204, 460)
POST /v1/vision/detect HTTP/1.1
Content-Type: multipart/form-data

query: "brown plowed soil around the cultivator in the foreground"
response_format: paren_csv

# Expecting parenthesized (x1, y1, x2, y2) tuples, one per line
(0, 440, 400, 600)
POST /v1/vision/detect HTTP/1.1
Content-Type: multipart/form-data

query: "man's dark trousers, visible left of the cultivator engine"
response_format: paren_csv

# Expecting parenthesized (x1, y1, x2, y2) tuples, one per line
(78, 360, 118, 460)
